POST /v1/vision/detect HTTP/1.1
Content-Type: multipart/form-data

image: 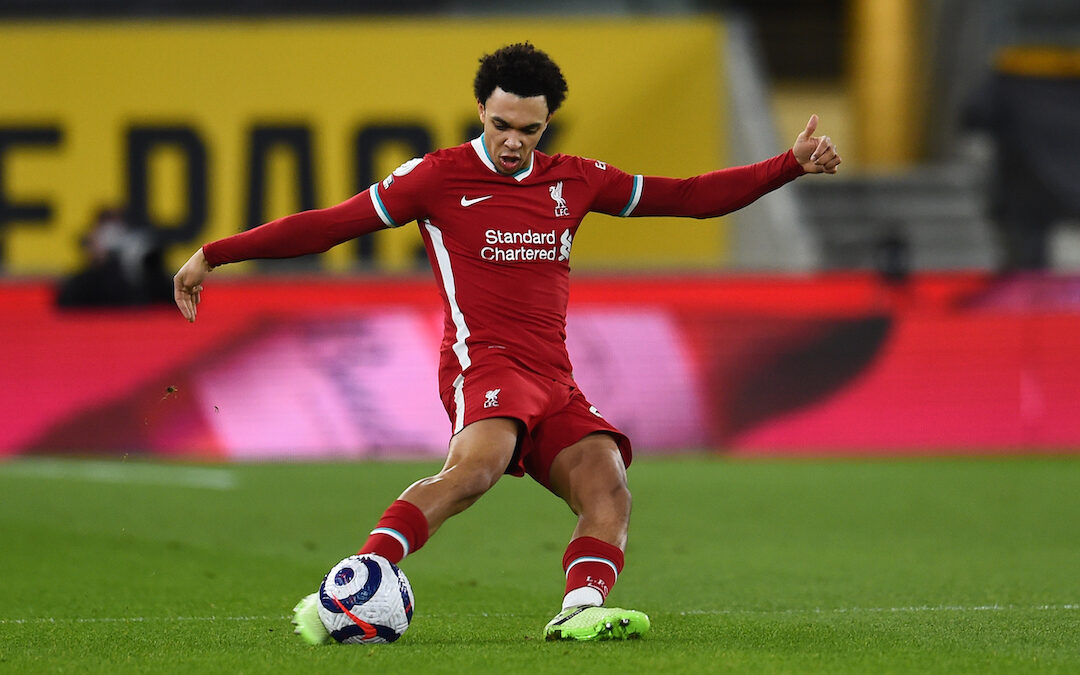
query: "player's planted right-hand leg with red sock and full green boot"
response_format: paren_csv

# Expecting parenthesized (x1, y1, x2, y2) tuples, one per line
(544, 432, 649, 639)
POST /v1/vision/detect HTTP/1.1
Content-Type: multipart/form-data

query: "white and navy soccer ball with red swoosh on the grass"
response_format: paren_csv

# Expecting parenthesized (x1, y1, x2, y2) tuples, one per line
(319, 553, 413, 645)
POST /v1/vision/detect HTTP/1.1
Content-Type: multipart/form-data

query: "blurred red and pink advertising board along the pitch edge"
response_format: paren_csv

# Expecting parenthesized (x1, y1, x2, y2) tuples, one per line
(6, 274, 1080, 460)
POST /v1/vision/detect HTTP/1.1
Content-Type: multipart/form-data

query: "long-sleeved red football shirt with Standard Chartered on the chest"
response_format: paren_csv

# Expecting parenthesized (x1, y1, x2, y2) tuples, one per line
(203, 137, 802, 395)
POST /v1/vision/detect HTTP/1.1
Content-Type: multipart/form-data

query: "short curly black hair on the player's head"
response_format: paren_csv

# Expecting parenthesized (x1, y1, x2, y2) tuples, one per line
(473, 42, 566, 112)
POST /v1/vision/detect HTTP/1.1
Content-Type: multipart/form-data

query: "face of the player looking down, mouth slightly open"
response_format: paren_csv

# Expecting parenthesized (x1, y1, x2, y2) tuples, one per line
(477, 87, 551, 175)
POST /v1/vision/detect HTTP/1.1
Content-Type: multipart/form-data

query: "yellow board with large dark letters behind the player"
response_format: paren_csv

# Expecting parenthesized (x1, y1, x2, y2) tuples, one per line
(0, 17, 727, 275)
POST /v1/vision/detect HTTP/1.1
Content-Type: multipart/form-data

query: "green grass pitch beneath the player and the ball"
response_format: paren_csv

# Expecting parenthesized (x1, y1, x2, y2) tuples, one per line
(0, 457, 1080, 674)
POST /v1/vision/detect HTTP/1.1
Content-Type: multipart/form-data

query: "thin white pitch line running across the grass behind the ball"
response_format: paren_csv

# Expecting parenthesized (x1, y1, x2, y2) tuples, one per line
(0, 604, 1080, 625)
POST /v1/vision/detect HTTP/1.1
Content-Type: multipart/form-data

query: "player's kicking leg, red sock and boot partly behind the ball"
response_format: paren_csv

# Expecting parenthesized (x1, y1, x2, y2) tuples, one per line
(293, 417, 519, 645)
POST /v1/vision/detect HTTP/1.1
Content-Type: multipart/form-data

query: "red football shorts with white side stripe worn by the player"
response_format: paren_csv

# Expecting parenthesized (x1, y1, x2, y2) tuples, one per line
(440, 359, 633, 489)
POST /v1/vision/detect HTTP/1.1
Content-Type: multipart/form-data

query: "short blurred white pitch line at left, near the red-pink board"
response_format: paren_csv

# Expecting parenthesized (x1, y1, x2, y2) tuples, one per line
(0, 458, 237, 490)
